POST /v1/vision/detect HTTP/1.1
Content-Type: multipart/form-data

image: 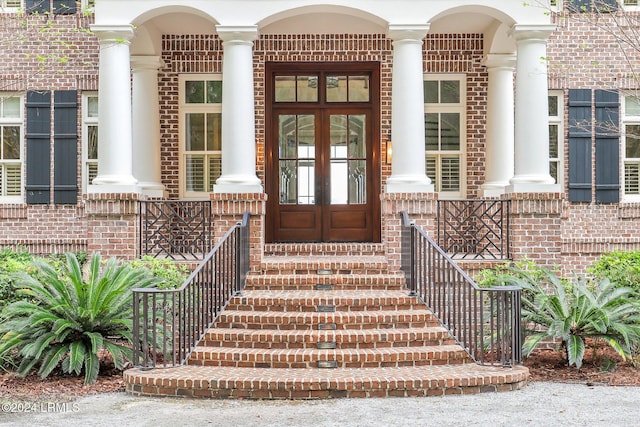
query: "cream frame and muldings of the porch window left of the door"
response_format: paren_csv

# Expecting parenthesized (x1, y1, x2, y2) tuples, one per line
(178, 73, 222, 199)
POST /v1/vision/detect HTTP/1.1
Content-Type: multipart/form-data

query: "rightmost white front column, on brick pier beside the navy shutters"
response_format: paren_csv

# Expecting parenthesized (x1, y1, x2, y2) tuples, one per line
(507, 25, 560, 193)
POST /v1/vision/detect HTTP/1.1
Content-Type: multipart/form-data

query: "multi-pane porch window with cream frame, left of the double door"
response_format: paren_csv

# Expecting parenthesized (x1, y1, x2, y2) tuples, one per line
(180, 75, 222, 197)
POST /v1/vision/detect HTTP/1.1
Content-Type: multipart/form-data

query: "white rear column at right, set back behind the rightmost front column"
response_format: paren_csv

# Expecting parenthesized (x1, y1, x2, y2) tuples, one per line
(480, 54, 516, 197)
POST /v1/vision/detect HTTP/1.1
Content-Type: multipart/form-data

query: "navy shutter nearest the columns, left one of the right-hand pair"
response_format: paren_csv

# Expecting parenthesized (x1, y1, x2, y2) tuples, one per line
(569, 89, 592, 202)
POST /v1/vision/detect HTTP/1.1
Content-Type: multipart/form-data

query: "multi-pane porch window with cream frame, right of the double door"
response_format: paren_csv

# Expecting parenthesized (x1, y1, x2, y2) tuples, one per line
(424, 74, 466, 198)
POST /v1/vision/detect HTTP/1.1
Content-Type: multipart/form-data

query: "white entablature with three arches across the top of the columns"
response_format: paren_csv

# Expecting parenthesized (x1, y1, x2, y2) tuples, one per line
(95, 0, 549, 32)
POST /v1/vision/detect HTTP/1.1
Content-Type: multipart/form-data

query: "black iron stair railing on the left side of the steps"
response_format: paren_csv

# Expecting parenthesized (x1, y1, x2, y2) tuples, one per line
(132, 213, 250, 368)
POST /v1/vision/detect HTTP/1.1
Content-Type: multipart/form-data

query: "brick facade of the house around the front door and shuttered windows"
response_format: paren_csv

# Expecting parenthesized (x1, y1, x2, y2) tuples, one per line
(0, 3, 640, 271)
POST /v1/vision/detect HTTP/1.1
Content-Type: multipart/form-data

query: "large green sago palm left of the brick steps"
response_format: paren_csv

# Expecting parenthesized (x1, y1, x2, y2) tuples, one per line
(0, 254, 156, 384)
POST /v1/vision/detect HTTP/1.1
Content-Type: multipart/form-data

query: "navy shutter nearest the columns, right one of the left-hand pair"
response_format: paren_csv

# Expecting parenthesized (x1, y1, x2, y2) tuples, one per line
(53, 90, 78, 204)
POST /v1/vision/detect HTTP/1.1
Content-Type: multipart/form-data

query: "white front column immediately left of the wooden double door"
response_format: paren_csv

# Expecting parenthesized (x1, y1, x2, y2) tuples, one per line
(213, 25, 263, 193)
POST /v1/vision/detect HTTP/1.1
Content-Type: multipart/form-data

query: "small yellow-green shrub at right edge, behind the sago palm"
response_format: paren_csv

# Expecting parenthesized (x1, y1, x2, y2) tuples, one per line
(587, 251, 640, 293)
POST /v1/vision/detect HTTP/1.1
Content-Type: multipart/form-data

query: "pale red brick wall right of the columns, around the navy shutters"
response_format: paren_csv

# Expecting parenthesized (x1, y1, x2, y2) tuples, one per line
(547, 8, 640, 274)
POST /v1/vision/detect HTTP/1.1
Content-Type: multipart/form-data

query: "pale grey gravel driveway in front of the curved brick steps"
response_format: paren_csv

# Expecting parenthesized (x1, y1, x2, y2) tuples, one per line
(0, 383, 640, 427)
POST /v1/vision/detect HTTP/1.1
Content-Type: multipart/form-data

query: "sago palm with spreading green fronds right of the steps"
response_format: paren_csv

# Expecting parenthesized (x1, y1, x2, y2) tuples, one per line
(513, 271, 640, 368)
